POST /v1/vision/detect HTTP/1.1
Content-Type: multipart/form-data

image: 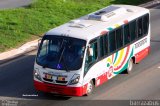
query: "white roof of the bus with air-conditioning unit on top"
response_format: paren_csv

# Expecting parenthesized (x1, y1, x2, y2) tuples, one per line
(46, 5, 149, 40)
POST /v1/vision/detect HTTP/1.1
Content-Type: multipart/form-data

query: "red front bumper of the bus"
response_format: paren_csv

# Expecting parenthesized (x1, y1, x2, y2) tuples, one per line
(34, 80, 87, 96)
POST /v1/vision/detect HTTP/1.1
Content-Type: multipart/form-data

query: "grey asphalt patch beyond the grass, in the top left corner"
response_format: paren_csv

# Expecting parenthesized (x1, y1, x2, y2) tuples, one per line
(0, 0, 32, 9)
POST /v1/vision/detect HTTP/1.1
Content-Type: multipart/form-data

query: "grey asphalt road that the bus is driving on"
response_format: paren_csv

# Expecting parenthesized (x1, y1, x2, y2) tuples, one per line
(0, 7, 160, 106)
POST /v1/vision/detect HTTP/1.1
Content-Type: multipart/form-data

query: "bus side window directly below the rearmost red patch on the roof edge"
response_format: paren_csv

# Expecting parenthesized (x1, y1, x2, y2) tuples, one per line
(123, 24, 130, 45)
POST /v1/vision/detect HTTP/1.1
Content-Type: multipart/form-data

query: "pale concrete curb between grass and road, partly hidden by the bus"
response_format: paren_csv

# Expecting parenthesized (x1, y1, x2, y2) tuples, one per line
(0, 0, 160, 65)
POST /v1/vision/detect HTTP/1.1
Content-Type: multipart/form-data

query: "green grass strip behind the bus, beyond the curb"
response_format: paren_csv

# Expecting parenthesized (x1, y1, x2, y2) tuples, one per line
(0, 0, 149, 52)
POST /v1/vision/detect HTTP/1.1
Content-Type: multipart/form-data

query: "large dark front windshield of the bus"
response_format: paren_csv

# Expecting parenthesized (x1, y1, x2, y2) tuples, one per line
(36, 35, 86, 71)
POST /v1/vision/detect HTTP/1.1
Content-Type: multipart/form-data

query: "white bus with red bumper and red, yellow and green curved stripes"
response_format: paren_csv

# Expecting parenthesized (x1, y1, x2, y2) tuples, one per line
(34, 5, 150, 96)
